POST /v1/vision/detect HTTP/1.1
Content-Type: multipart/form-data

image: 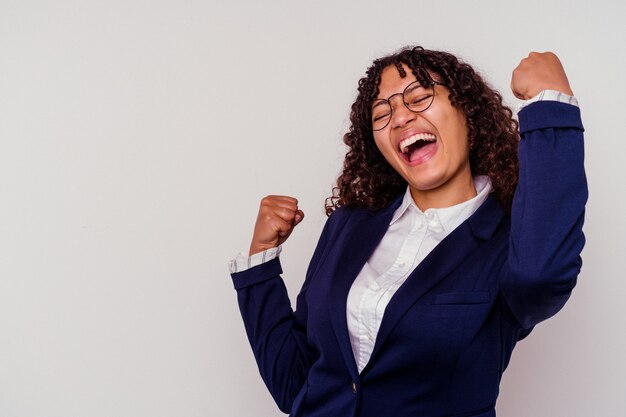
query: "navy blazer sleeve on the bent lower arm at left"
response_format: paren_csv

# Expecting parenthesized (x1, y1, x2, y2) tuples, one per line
(231, 212, 340, 413)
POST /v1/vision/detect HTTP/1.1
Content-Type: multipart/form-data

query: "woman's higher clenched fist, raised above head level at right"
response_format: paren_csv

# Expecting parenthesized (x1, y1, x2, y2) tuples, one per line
(511, 52, 574, 100)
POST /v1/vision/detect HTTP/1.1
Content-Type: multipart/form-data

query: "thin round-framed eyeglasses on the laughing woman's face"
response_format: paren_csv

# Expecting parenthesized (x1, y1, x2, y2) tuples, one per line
(372, 81, 445, 130)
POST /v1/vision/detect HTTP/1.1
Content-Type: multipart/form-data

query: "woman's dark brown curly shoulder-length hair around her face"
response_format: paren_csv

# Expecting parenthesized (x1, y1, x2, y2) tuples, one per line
(325, 46, 519, 216)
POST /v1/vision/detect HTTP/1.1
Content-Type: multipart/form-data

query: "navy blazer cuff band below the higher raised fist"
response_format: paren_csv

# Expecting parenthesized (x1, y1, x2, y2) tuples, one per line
(518, 101, 585, 134)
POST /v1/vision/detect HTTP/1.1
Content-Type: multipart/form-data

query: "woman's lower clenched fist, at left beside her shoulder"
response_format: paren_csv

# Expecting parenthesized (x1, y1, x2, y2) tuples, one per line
(250, 195, 304, 255)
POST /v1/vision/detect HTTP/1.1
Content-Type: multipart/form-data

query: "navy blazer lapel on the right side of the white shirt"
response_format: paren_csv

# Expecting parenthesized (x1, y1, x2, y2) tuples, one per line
(364, 195, 504, 371)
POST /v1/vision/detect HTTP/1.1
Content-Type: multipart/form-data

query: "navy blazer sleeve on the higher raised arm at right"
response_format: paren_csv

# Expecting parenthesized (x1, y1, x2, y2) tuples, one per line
(501, 101, 587, 329)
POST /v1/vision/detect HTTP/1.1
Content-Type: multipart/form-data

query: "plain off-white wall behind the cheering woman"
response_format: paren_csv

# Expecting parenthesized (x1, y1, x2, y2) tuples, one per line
(0, 0, 626, 417)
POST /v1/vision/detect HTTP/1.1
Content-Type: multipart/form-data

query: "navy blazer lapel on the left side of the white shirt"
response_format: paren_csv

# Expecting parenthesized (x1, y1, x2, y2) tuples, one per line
(329, 195, 402, 378)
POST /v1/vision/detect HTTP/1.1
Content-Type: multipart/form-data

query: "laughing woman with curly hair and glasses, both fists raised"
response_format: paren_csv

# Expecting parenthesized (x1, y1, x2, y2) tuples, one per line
(231, 48, 587, 417)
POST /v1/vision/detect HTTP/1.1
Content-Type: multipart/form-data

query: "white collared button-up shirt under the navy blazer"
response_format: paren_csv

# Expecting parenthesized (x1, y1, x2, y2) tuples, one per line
(346, 176, 492, 372)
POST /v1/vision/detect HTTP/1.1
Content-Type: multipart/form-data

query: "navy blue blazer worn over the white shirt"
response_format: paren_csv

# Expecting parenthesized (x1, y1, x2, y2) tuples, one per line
(232, 102, 587, 417)
